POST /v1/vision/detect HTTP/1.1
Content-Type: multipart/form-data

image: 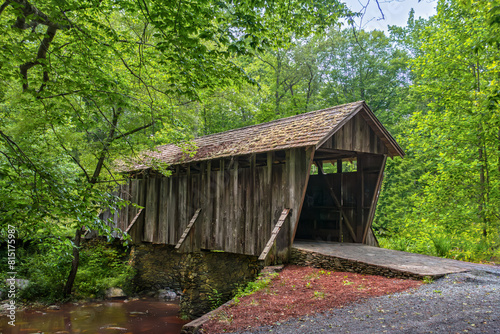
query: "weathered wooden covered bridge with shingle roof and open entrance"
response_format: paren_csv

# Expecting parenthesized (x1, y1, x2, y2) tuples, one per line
(108, 102, 404, 262)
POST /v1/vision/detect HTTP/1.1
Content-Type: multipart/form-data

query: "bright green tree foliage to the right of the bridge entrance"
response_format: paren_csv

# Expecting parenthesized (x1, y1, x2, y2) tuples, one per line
(376, 0, 500, 259)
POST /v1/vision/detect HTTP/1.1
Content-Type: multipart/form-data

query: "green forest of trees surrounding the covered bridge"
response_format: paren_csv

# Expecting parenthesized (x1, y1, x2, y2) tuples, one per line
(0, 0, 500, 299)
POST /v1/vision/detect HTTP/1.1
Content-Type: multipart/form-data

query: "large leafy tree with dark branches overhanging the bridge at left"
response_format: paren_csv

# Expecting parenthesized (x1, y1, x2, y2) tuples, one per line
(0, 0, 346, 295)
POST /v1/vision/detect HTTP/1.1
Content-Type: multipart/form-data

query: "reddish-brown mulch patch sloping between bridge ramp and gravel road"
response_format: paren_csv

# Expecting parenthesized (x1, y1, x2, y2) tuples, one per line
(203, 266, 422, 334)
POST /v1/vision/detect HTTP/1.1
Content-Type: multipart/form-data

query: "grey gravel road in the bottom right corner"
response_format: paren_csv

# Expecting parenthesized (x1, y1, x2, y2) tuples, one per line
(236, 267, 500, 334)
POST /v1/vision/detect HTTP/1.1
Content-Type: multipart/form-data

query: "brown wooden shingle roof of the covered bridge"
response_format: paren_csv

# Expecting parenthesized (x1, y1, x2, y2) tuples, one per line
(127, 101, 397, 170)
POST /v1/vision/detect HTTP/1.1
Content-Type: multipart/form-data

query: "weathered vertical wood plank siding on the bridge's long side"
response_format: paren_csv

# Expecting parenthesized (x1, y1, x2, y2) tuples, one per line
(117, 148, 312, 260)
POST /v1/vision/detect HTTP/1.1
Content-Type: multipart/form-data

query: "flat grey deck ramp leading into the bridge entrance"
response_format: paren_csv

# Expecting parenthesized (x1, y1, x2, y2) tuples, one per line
(293, 240, 495, 277)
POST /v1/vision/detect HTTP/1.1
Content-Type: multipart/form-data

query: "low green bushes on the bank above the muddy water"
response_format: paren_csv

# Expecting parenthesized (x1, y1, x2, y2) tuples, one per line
(0, 238, 134, 303)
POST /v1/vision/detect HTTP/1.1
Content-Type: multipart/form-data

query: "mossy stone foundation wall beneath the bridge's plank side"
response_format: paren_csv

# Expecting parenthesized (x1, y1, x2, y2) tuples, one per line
(131, 244, 262, 319)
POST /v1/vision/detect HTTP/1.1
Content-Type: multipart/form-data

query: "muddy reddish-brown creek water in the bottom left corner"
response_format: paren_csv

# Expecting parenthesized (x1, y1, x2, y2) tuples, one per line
(0, 300, 186, 334)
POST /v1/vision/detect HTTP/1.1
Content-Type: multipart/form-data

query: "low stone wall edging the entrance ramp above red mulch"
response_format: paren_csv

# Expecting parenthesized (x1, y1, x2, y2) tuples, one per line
(290, 248, 423, 280)
